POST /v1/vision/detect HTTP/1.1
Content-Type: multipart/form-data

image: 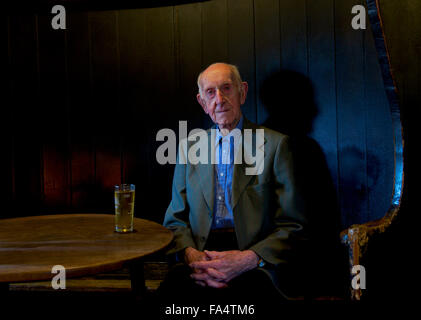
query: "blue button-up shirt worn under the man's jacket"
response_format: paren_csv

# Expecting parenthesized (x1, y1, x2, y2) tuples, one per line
(212, 116, 243, 229)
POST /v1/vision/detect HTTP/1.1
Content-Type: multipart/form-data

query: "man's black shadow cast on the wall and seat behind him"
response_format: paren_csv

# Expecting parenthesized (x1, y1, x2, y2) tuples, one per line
(260, 70, 349, 295)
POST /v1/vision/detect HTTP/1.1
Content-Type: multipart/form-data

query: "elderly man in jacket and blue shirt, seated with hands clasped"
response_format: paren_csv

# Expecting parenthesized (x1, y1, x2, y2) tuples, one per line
(160, 63, 307, 303)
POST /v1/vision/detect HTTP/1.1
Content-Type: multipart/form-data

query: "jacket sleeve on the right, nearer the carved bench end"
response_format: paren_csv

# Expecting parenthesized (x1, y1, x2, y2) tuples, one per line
(249, 136, 307, 266)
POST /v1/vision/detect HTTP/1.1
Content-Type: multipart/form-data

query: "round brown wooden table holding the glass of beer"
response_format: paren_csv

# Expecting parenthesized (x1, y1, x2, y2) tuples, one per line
(0, 214, 173, 289)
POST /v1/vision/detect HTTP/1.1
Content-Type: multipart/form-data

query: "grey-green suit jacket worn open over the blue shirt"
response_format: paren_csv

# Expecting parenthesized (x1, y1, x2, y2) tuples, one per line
(164, 119, 307, 295)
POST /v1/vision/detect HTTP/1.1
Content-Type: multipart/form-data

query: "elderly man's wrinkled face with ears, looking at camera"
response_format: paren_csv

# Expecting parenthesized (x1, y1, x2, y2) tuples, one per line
(197, 64, 247, 130)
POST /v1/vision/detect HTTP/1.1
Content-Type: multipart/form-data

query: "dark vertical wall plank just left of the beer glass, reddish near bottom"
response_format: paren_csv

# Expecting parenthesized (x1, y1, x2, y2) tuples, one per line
(89, 11, 120, 212)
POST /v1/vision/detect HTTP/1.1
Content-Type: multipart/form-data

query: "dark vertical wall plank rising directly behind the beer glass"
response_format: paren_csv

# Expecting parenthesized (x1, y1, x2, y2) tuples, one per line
(118, 10, 149, 200)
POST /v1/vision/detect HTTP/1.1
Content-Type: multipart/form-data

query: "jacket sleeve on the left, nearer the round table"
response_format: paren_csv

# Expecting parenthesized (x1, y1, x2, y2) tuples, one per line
(163, 146, 197, 254)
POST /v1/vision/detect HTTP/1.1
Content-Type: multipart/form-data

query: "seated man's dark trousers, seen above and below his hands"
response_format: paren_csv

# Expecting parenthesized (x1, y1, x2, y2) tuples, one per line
(153, 233, 286, 319)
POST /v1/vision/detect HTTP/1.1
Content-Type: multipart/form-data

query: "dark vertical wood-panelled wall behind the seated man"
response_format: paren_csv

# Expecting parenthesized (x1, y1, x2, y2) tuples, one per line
(3, 0, 398, 231)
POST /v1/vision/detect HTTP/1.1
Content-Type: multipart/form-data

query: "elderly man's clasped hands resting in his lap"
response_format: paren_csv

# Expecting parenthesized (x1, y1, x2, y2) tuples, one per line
(184, 247, 259, 288)
